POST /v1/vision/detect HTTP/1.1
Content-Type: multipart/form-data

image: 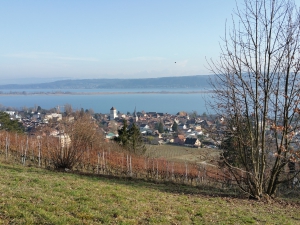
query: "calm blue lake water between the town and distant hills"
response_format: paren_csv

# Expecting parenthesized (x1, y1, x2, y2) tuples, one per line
(0, 89, 210, 114)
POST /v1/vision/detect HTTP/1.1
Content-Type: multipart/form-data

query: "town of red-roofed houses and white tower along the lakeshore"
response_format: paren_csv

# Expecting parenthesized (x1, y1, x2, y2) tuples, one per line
(4, 105, 225, 148)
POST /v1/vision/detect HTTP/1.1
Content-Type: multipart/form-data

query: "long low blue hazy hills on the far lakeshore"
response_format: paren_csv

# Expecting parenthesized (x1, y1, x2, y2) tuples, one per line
(0, 75, 211, 89)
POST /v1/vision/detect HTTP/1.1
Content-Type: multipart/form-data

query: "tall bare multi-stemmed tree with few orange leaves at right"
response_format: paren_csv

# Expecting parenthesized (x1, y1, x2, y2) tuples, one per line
(209, 0, 300, 199)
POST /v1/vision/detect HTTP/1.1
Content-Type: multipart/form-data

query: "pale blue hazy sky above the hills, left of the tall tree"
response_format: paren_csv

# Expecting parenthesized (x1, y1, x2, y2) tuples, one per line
(0, 0, 298, 83)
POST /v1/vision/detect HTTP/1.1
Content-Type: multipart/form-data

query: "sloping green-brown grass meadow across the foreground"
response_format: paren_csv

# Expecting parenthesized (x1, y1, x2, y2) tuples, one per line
(0, 162, 300, 224)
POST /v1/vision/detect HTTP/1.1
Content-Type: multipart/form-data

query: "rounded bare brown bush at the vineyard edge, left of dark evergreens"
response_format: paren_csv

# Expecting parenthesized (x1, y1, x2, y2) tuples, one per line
(48, 112, 103, 169)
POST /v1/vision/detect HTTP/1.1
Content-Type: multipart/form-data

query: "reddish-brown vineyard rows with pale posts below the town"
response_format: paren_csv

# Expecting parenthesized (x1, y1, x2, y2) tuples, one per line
(0, 132, 300, 195)
